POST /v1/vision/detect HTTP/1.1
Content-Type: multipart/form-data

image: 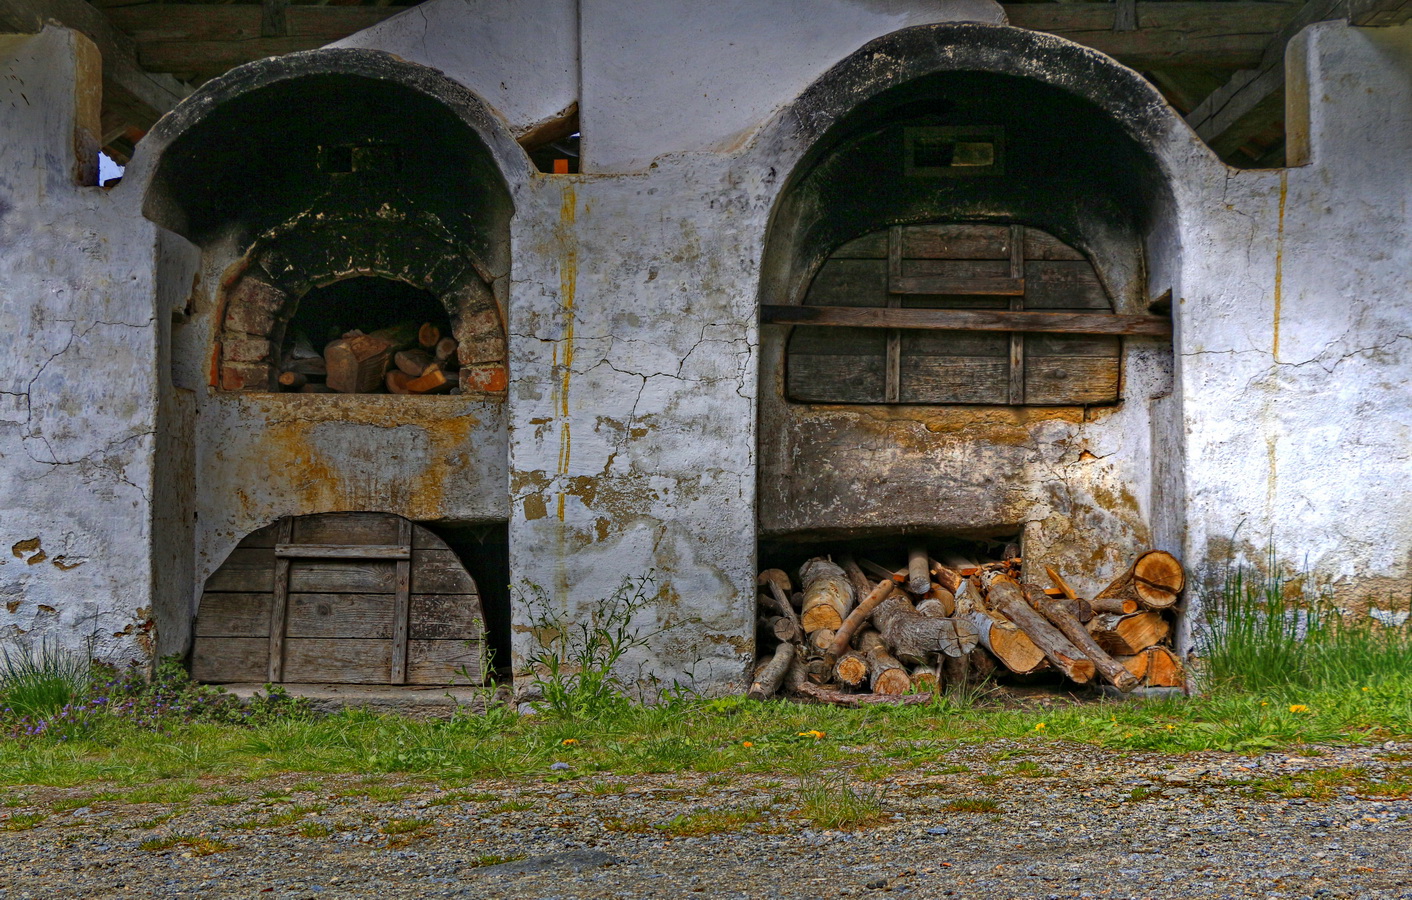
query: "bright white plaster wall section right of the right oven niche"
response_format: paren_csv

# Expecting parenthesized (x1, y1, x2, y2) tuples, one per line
(1179, 23, 1412, 603)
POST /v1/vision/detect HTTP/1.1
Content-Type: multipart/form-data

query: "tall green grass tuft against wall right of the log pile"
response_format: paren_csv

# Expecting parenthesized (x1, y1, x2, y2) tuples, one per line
(1200, 552, 1412, 694)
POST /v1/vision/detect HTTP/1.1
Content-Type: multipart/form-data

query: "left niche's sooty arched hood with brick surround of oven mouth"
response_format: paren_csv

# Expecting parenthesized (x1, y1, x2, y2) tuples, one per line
(137, 49, 528, 391)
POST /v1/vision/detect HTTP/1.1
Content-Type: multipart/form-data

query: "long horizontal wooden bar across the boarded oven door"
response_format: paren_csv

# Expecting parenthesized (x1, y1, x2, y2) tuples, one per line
(760, 305, 1172, 338)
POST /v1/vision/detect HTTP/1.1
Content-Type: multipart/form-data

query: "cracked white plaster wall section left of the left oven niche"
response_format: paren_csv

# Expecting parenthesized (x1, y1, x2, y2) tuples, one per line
(0, 27, 180, 660)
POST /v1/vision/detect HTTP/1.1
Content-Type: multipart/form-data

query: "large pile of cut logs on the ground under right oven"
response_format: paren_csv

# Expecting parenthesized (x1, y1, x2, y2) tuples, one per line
(750, 545, 1185, 706)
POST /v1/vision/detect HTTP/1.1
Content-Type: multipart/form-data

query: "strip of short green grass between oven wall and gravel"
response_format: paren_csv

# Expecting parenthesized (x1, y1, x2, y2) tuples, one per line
(0, 678, 1412, 804)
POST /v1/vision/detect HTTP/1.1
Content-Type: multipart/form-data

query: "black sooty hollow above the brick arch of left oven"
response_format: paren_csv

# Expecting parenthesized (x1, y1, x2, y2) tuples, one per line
(144, 63, 511, 261)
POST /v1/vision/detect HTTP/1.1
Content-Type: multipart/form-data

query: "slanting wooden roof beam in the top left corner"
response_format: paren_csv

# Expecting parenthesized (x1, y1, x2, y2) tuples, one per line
(0, 0, 191, 130)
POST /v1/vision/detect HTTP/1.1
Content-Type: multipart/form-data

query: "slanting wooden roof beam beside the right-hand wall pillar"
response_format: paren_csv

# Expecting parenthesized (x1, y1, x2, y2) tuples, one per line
(1186, 0, 1348, 158)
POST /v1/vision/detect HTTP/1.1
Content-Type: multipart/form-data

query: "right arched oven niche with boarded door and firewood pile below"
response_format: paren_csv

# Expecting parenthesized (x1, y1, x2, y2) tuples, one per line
(758, 50, 1185, 702)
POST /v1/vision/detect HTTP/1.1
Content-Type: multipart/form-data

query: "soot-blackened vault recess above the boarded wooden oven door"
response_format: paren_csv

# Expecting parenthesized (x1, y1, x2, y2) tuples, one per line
(771, 72, 1166, 310)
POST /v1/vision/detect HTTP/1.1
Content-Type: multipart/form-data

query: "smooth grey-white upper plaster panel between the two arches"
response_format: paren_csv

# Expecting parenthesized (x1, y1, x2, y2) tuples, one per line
(580, 0, 1005, 174)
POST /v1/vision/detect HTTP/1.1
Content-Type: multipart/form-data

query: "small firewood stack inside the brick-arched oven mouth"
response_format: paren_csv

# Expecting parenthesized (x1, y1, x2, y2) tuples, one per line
(280, 322, 460, 394)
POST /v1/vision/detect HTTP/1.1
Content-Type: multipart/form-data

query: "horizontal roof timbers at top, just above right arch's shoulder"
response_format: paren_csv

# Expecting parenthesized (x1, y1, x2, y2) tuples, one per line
(1004, 0, 1299, 69)
